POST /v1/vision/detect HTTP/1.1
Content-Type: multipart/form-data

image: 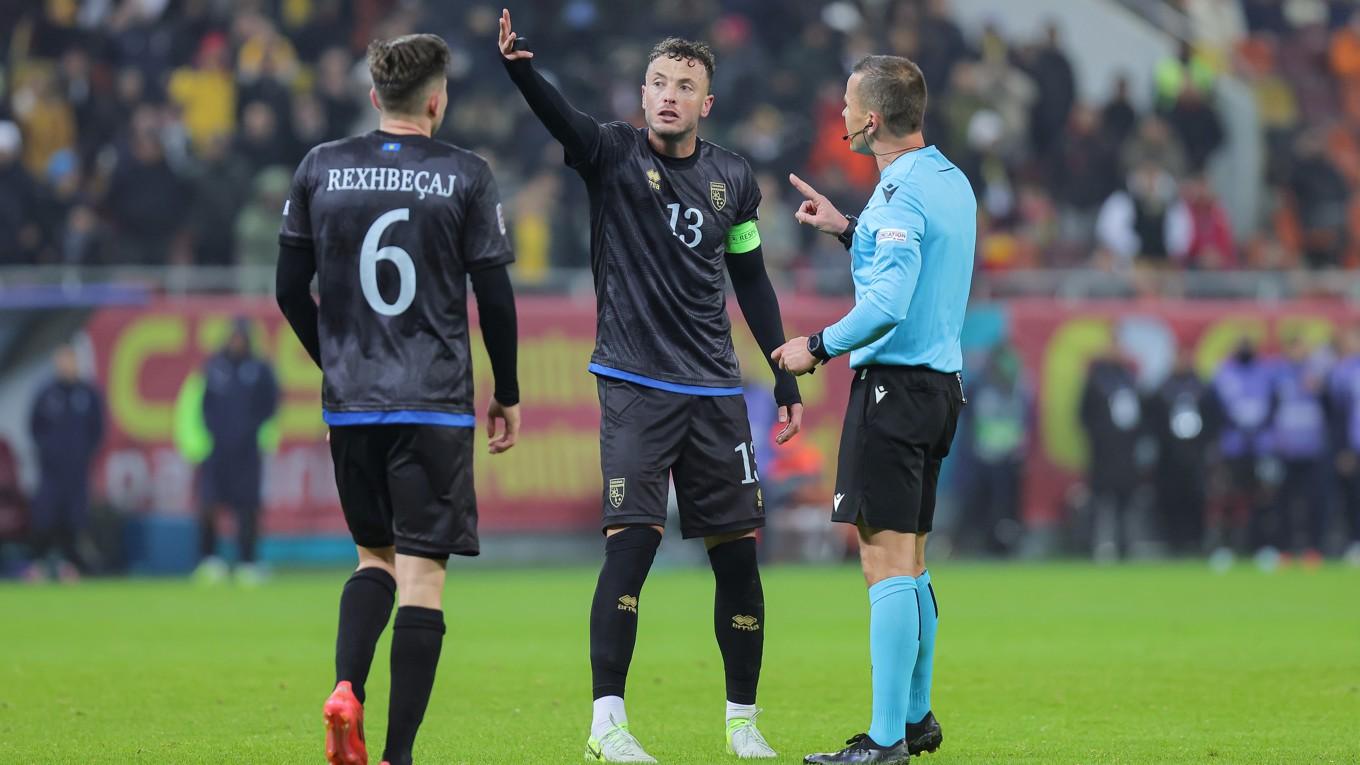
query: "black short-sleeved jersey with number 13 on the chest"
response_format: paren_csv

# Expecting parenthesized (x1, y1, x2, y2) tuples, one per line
(567, 123, 760, 388)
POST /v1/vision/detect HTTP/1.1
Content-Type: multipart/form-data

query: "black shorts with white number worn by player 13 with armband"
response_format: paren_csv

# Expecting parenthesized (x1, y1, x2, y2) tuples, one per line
(596, 377, 764, 539)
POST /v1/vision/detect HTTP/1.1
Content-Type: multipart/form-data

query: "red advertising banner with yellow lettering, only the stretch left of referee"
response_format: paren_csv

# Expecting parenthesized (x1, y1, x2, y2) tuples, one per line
(87, 298, 850, 534)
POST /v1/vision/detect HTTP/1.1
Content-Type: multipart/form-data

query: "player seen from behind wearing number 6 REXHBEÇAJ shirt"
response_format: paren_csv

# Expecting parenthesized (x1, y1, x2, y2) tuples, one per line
(277, 34, 520, 765)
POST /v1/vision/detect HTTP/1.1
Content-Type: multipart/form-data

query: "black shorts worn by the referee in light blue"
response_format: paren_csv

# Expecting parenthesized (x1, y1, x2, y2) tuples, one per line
(831, 366, 964, 534)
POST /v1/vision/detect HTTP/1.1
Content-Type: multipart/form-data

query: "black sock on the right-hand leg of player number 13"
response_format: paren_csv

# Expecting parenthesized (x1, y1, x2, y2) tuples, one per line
(709, 536, 764, 704)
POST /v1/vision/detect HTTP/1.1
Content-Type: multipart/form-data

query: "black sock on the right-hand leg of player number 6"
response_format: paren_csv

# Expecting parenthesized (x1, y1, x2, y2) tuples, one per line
(382, 606, 443, 765)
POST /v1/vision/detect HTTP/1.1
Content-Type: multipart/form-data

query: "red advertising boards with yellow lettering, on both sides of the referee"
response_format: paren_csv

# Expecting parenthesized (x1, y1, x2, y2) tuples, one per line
(88, 291, 1360, 534)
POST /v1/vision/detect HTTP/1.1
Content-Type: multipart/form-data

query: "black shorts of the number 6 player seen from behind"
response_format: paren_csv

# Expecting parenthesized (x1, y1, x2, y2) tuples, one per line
(330, 425, 480, 559)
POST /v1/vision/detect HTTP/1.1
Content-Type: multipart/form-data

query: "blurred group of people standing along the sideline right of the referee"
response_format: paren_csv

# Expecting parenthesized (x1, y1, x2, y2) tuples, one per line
(949, 327, 1360, 568)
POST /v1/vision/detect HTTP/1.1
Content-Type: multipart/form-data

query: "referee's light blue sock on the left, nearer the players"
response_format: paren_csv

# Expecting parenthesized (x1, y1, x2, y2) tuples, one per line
(869, 576, 921, 746)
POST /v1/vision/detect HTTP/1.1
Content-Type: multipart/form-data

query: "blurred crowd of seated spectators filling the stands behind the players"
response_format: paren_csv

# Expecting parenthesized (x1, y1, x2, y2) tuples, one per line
(0, 0, 1360, 280)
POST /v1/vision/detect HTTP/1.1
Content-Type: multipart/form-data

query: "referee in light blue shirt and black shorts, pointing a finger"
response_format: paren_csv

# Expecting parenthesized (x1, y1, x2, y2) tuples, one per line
(772, 56, 978, 764)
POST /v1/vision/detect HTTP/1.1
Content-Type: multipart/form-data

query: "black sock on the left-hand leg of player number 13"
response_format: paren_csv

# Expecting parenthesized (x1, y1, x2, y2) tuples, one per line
(590, 525, 661, 698)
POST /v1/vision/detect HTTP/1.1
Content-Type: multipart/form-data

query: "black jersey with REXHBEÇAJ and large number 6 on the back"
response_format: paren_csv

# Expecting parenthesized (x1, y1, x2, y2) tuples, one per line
(279, 131, 514, 426)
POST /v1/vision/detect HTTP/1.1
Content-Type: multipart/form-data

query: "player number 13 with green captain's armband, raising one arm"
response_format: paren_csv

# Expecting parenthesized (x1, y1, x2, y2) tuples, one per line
(499, 11, 802, 762)
